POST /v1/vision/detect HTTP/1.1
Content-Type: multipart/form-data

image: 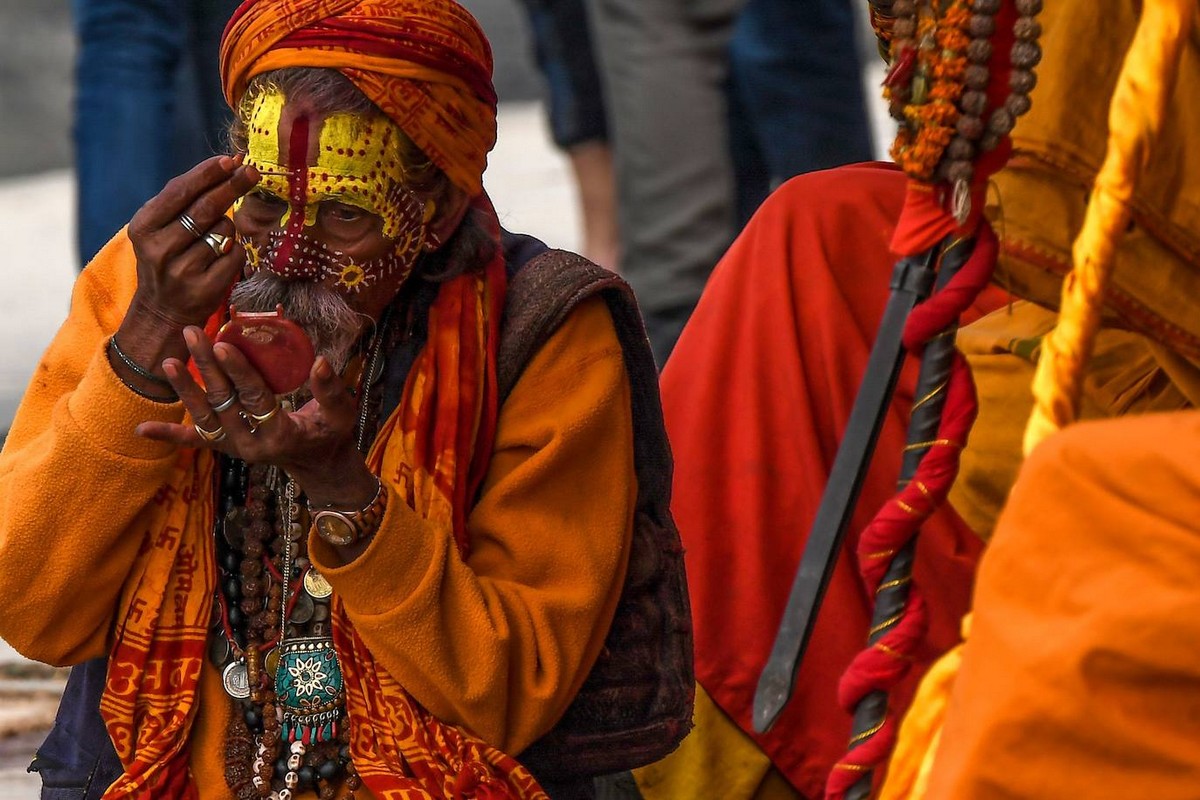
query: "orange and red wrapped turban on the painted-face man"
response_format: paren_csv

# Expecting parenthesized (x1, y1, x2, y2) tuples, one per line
(221, 0, 496, 196)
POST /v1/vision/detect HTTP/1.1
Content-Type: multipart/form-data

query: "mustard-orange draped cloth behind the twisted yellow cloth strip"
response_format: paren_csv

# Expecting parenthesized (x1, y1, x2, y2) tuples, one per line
(989, 0, 1200, 359)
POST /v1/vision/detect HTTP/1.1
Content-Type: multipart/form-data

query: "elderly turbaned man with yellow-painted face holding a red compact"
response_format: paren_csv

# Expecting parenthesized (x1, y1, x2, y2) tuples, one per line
(0, 0, 691, 799)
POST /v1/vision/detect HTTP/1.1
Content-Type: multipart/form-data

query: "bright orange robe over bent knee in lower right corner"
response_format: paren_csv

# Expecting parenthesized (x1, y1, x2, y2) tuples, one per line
(925, 411, 1200, 800)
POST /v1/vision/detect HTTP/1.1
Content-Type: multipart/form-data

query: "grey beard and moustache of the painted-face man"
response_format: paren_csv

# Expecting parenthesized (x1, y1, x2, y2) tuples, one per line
(229, 270, 371, 374)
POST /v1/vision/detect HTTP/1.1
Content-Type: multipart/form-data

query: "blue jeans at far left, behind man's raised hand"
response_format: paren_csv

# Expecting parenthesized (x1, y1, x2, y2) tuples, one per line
(73, 0, 238, 263)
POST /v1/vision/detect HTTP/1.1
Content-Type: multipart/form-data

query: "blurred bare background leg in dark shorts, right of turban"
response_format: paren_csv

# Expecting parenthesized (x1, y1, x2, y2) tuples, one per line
(523, 0, 619, 269)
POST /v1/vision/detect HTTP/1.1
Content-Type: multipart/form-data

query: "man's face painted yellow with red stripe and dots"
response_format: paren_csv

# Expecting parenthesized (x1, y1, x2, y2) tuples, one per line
(234, 91, 434, 305)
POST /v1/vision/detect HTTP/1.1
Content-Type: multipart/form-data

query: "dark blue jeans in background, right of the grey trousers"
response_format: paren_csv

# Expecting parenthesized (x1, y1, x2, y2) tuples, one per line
(730, 0, 871, 224)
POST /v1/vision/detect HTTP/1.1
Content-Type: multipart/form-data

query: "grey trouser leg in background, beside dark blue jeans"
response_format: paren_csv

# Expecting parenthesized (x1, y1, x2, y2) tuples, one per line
(589, 0, 743, 367)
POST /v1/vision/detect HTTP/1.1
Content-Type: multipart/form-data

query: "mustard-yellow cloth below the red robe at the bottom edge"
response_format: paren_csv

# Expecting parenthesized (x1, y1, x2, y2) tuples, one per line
(634, 684, 800, 800)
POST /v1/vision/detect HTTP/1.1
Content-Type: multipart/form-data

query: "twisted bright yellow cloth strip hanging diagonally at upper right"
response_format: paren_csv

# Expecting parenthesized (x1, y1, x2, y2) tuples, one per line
(1024, 0, 1196, 455)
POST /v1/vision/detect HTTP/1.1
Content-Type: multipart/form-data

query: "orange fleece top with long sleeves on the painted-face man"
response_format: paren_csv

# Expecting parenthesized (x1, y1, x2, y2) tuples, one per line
(0, 234, 636, 798)
